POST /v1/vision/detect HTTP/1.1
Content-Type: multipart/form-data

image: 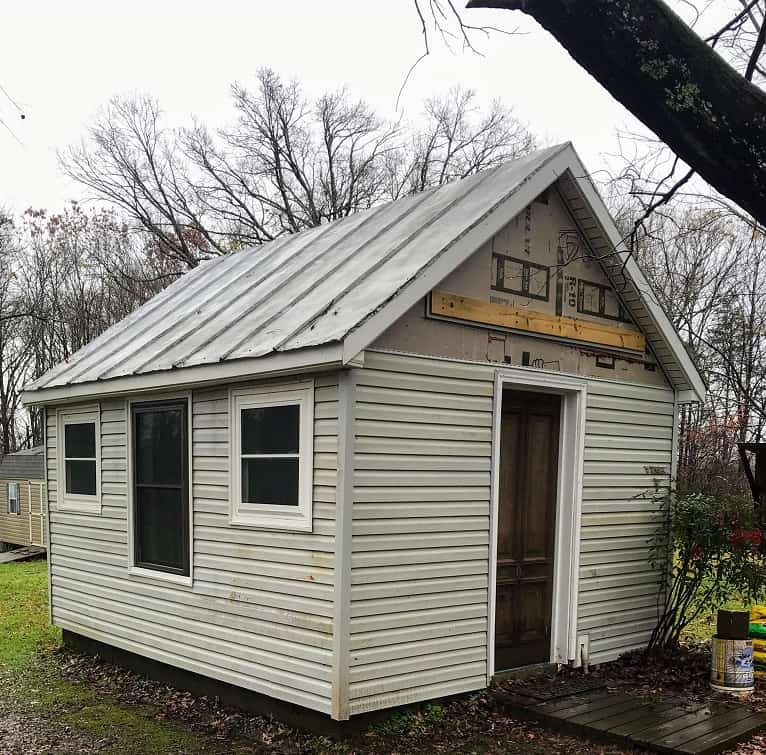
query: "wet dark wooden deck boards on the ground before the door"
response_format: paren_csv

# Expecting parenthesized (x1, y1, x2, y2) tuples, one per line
(505, 686, 766, 755)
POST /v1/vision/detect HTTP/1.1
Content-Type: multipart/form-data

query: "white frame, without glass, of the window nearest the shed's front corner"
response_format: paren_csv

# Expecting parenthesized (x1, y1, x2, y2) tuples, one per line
(229, 380, 314, 532)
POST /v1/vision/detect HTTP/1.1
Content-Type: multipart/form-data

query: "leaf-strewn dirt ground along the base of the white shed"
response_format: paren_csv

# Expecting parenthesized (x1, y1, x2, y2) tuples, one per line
(0, 650, 648, 755)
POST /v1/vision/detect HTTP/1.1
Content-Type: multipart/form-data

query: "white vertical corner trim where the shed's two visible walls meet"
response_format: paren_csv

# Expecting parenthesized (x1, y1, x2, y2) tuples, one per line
(332, 369, 356, 721)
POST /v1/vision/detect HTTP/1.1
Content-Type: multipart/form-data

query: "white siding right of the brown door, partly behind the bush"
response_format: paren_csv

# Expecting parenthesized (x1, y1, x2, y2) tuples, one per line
(578, 380, 674, 663)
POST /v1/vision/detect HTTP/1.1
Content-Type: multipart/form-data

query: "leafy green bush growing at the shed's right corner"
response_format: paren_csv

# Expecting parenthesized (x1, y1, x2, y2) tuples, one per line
(649, 493, 766, 650)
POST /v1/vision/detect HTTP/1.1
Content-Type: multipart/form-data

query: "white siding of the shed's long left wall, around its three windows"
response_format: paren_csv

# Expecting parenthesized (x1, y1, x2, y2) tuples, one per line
(47, 376, 337, 712)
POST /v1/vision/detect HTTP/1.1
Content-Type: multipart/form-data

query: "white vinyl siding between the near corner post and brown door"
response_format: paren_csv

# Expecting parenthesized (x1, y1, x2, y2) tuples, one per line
(349, 354, 493, 714)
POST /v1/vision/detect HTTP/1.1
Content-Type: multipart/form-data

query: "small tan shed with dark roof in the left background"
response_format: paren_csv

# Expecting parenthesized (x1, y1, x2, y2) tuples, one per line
(0, 446, 46, 546)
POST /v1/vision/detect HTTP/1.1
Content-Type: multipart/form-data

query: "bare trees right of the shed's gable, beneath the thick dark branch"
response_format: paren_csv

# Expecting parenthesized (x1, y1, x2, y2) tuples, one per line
(620, 202, 766, 494)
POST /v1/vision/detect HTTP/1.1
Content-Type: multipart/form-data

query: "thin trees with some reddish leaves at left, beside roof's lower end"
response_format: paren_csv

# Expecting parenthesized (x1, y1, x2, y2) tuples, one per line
(0, 204, 176, 456)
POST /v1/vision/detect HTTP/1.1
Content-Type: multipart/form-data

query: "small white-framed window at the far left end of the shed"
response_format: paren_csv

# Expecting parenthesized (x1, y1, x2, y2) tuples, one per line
(58, 407, 101, 513)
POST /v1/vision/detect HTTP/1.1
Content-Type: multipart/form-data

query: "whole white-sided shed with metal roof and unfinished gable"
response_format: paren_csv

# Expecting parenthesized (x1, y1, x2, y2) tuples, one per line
(24, 144, 705, 720)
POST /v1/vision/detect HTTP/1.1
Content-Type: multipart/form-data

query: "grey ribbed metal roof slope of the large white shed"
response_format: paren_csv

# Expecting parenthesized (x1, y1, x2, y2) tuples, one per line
(24, 144, 708, 402)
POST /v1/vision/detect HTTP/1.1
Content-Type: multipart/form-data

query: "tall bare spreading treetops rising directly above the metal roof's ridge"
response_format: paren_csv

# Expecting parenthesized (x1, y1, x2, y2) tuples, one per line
(61, 69, 535, 267)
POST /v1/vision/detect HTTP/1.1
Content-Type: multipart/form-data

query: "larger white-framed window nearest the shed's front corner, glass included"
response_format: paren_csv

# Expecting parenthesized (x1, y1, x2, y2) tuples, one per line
(231, 383, 314, 531)
